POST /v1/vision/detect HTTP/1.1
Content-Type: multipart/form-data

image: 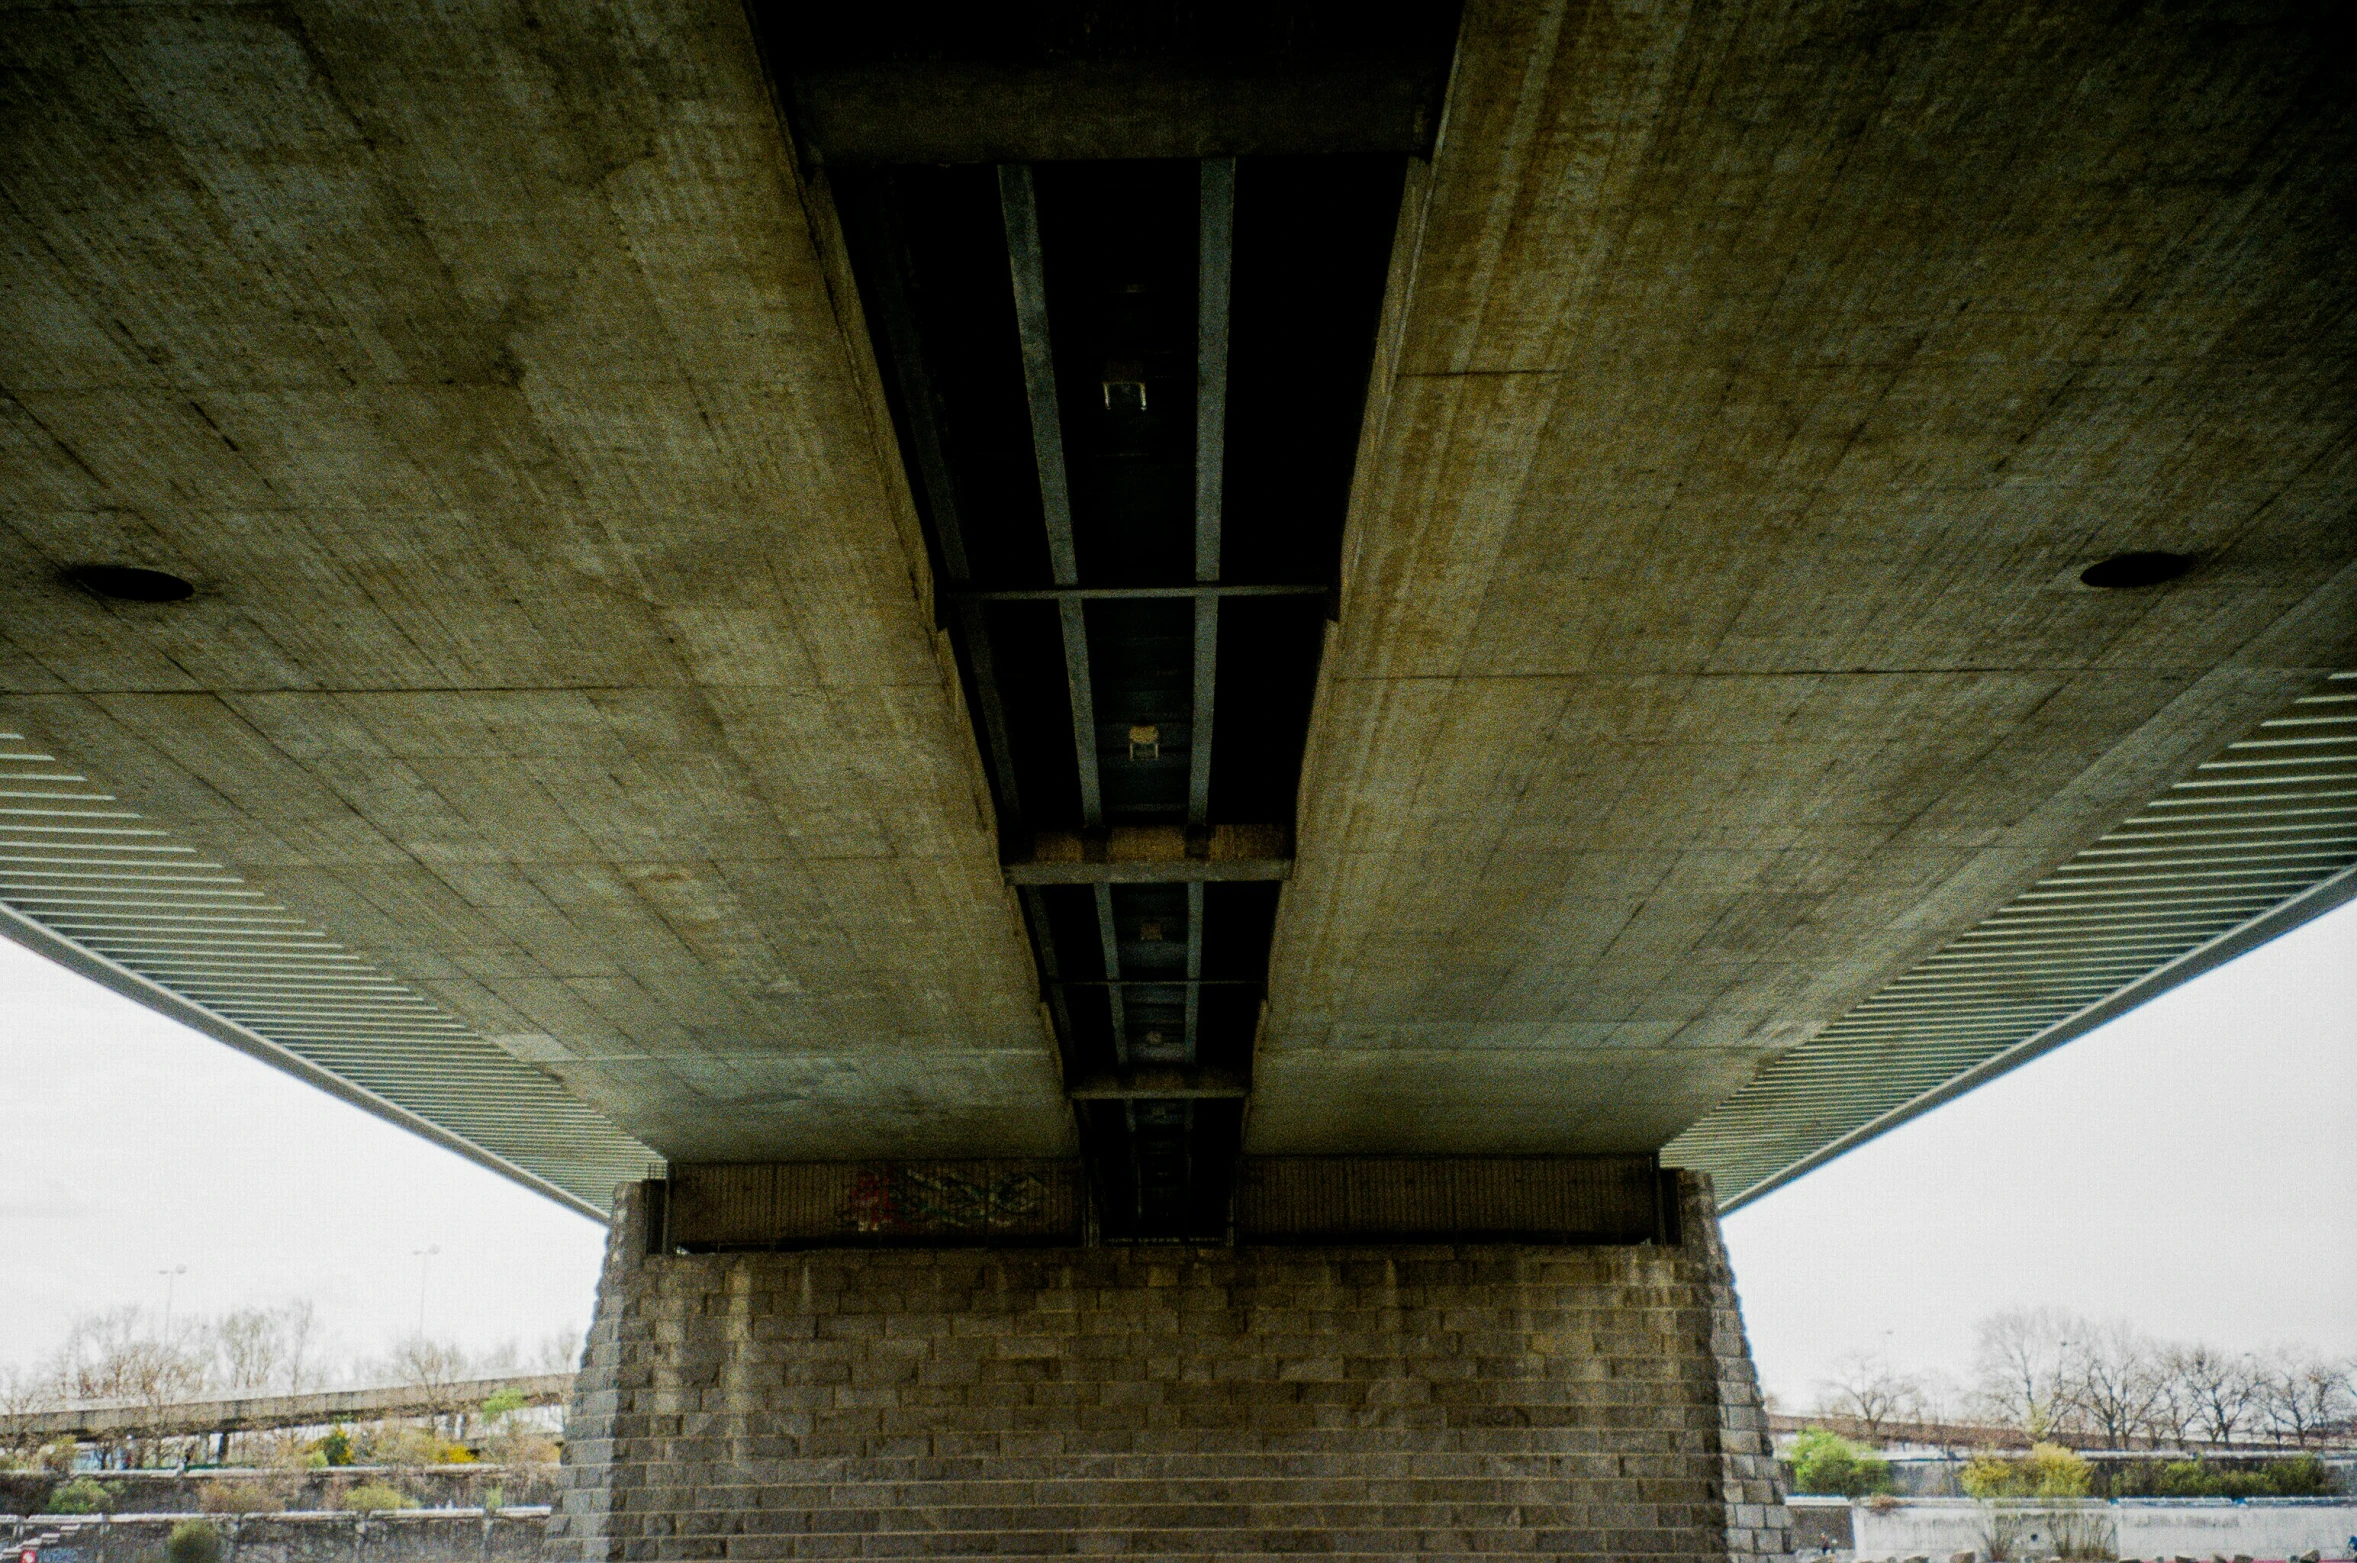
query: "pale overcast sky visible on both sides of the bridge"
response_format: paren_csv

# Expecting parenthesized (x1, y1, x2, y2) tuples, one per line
(0, 905, 2357, 1405)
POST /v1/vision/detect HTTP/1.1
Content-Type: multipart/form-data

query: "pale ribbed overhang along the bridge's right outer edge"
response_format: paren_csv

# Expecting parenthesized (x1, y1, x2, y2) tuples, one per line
(1662, 672, 2357, 1209)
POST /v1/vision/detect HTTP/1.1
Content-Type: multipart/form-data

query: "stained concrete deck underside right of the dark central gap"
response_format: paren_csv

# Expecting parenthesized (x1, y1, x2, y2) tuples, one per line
(1249, 0, 2357, 1153)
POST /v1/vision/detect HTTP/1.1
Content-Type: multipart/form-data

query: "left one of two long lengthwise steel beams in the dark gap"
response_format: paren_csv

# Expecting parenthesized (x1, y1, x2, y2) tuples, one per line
(999, 163, 1105, 830)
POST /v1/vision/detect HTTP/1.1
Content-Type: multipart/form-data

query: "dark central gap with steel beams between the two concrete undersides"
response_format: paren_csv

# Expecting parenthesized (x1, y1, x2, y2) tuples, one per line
(815, 149, 1385, 1242)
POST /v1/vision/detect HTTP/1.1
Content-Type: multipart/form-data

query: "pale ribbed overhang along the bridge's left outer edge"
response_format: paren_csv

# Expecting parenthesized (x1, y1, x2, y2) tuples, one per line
(0, 733, 658, 1219)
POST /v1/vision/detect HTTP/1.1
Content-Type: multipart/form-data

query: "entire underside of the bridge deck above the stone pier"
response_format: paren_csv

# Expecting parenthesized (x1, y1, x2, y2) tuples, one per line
(0, 0, 2357, 1556)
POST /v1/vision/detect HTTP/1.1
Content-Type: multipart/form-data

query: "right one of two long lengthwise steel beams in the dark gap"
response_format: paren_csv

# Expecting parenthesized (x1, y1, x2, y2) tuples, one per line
(1186, 158, 1235, 839)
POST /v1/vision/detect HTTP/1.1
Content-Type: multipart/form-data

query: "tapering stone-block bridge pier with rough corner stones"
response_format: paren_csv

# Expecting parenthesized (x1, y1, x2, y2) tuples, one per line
(549, 1172, 1791, 1563)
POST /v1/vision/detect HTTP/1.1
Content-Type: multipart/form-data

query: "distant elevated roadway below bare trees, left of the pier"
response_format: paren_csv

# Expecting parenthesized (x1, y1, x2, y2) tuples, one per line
(0, 1372, 573, 1443)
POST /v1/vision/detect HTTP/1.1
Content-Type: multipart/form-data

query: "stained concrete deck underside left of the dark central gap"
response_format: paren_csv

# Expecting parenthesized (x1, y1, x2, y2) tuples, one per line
(0, 0, 1070, 1155)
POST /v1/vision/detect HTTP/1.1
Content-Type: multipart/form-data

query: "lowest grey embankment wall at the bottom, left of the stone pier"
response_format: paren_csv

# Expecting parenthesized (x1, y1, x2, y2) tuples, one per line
(0, 1506, 549, 1563)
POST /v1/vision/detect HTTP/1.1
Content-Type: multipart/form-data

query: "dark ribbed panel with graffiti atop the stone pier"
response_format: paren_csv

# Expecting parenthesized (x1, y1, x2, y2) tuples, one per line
(667, 1158, 1087, 1249)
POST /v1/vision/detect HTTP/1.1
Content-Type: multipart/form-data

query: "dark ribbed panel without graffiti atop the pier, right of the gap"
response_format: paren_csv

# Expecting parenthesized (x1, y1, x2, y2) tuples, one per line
(1235, 1155, 1662, 1242)
